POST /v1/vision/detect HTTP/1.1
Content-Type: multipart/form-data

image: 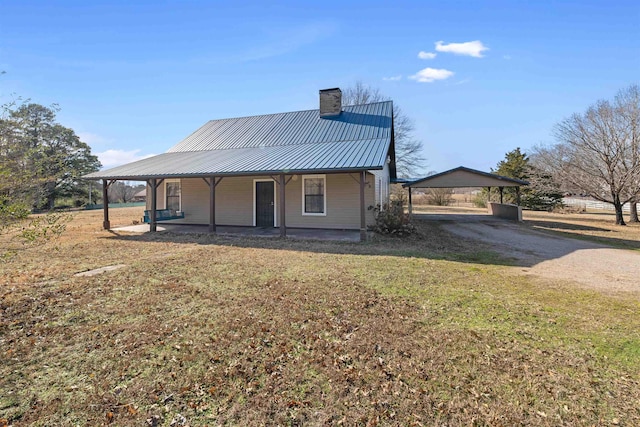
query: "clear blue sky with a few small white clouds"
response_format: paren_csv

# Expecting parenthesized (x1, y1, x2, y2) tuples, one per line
(0, 0, 640, 176)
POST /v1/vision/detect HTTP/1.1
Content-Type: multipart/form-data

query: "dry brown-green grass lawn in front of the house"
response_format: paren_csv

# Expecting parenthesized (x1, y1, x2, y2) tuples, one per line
(0, 208, 640, 426)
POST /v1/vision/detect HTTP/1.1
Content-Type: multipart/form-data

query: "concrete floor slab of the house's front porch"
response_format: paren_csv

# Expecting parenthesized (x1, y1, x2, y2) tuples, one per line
(112, 223, 360, 242)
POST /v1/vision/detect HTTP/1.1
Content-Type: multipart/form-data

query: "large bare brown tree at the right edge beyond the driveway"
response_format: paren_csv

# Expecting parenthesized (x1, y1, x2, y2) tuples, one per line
(536, 85, 640, 225)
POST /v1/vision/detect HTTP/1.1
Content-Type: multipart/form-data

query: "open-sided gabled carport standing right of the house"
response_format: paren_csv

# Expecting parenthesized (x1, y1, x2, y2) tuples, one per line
(402, 166, 529, 221)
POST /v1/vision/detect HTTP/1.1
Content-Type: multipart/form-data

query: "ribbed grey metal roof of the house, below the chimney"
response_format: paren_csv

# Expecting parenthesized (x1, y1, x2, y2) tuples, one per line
(85, 101, 393, 180)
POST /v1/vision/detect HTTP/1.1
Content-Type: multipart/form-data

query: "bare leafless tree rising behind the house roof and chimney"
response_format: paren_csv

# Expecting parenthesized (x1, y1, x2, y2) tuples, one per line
(342, 81, 426, 177)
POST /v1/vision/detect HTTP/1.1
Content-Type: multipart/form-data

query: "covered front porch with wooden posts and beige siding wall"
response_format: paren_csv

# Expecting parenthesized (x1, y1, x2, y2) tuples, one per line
(97, 170, 375, 240)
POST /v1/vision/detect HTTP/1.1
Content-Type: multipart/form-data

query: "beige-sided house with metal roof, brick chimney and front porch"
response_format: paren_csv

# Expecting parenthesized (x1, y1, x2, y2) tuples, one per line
(85, 88, 396, 238)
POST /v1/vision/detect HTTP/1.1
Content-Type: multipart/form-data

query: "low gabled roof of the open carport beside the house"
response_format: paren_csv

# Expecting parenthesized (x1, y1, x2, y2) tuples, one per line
(402, 166, 529, 188)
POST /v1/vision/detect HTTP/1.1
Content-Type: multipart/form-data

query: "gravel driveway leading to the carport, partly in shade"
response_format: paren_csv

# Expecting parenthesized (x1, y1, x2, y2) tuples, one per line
(425, 215, 640, 292)
